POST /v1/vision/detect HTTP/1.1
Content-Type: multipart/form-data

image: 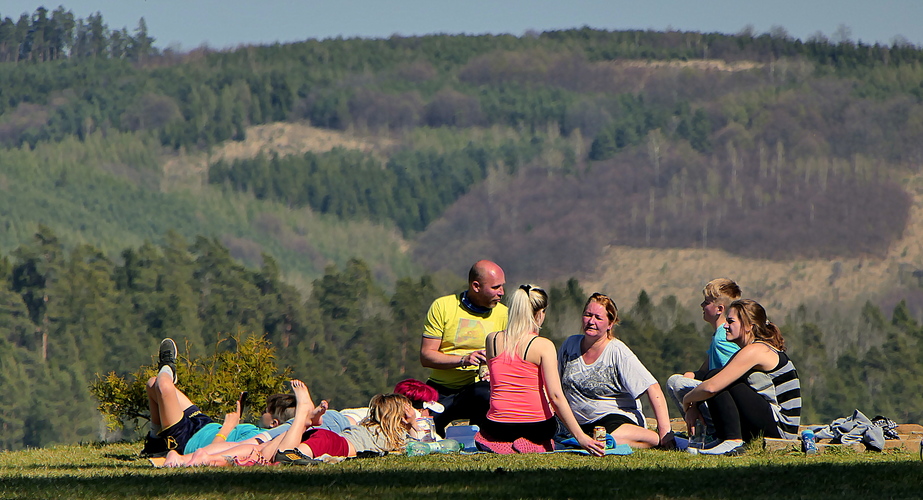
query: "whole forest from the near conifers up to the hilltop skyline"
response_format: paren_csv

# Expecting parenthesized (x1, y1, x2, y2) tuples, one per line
(0, 7, 923, 449)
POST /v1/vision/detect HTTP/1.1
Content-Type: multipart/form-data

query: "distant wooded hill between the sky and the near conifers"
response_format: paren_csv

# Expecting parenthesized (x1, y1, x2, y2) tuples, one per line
(7, 12, 923, 308)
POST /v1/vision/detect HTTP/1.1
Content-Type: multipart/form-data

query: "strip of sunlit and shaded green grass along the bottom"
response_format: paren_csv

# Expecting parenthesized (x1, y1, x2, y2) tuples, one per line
(0, 443, 923, 500)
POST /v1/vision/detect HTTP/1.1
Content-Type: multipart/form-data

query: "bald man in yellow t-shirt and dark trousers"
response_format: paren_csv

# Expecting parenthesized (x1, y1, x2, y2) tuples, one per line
(420, 260, 507, 436)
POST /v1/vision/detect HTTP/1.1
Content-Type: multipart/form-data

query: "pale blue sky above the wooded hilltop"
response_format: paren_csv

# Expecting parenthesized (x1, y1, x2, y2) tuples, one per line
(0, 0, 923, 49)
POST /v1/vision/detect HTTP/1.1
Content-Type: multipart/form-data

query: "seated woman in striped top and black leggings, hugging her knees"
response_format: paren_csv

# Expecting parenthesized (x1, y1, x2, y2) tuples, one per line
(683, 299, 801, 455)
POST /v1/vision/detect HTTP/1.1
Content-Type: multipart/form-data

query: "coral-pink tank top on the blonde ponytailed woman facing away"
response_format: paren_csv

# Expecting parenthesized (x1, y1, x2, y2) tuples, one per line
(487, 336, 554, 423)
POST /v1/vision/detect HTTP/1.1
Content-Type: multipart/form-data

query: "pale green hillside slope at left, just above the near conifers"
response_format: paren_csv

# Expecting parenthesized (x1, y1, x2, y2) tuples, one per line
(0, 130, 419, 290)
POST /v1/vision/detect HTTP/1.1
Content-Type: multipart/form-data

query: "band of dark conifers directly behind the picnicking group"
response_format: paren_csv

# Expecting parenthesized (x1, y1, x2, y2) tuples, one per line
(0, 227, 923, 449)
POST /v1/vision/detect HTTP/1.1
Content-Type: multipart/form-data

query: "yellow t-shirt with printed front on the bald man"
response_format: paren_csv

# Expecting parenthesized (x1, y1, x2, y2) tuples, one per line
(423, 294, 507, 389)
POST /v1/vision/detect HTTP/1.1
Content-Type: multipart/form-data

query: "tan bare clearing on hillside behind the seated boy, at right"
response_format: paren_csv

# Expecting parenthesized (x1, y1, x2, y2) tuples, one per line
(580, 176, 923, 314)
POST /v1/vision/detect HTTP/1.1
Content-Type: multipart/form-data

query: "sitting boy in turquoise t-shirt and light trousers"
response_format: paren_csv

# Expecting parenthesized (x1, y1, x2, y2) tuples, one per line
(667, 278, 740, 435)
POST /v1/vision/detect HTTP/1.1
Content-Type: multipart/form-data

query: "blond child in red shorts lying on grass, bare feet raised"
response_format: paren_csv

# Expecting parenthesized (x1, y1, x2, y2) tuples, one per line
(164, 380, 416, 467)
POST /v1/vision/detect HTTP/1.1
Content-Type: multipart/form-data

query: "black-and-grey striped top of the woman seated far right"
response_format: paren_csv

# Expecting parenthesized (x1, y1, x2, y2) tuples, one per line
(747, 342, 801, 439)
